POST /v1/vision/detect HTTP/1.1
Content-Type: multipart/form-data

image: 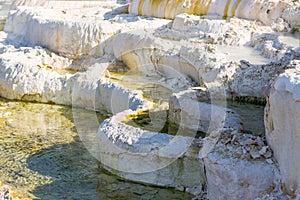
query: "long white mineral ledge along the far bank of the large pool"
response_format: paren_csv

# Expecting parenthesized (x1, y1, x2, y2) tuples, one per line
(0, 32, 152, 113)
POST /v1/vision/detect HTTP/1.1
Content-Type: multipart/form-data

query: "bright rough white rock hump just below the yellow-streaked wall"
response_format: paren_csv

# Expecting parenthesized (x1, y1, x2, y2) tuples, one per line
(163, 14, 259, 45)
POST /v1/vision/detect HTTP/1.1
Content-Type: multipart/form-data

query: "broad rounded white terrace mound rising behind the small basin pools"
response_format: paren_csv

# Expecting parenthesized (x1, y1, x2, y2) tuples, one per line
(95, 15, 299, 101)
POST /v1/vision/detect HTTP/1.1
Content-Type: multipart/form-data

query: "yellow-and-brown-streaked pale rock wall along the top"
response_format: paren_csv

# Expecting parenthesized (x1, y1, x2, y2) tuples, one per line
(129, 0, 284, 24)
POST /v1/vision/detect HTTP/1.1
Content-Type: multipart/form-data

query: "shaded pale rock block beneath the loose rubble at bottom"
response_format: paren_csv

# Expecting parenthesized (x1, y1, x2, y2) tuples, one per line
(204, 151, 278, 200)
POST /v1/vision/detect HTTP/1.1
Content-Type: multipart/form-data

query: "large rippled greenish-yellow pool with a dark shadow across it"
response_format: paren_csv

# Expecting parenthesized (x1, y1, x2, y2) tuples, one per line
(0, 99, 192, 199)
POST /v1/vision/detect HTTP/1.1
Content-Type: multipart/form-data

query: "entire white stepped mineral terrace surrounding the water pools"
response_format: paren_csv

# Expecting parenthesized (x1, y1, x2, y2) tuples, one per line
(0, 0, 300, 199)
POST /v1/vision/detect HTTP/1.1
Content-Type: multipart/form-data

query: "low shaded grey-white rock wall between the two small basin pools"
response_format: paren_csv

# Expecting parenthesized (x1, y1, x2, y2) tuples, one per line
(169, 89, 243, 133)
